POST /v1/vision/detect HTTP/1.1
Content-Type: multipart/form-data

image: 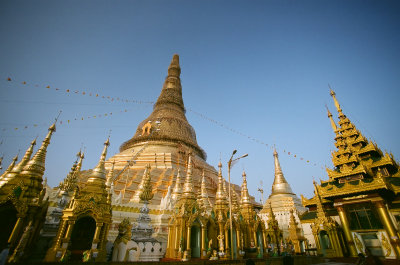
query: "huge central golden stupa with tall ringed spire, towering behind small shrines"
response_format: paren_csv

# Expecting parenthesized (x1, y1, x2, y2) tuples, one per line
(80, 54, 240, 242)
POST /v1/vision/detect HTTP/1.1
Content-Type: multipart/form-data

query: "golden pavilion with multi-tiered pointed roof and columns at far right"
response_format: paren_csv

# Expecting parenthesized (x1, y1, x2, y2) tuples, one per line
(301, 90, 400, 259)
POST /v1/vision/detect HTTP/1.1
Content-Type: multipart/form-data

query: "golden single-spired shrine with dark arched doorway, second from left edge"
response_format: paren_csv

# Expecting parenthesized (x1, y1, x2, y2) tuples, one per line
(45, 139, 111, 261)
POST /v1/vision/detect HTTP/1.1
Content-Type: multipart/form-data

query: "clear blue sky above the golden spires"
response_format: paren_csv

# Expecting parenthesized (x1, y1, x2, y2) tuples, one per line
(0, 1, 400, 199)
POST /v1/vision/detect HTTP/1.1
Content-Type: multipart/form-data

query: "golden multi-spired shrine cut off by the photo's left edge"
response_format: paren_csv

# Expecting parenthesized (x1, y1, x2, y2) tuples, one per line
(0, 123, 56, 262)
